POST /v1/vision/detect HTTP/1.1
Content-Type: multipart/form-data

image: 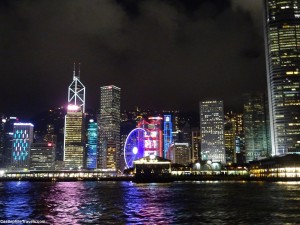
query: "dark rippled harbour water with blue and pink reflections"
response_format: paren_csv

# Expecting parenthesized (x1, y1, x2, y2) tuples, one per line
(0, 181, 300, 225)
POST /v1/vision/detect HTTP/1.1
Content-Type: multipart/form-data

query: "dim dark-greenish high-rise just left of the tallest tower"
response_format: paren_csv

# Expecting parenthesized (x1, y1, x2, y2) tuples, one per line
(243, 93, 270, 162)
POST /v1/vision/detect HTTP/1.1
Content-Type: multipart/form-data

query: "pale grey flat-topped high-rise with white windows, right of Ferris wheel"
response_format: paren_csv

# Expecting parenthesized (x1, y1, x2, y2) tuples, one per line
(200, 100, 226, 163)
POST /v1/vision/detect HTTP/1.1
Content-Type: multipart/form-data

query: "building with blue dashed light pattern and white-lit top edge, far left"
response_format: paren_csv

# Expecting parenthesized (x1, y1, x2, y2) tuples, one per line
(11, 123, 33, 170)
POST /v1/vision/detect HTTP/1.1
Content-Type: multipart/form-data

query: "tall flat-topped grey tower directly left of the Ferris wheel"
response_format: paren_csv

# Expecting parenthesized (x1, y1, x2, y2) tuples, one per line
(97, 85, 122, 171)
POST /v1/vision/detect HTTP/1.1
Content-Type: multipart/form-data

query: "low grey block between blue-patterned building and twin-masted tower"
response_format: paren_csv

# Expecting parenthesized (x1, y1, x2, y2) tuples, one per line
(30, 142, 55, 170)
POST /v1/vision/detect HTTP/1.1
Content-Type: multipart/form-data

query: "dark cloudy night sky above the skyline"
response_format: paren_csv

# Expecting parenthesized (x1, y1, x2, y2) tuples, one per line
(0, 0, 266, 117)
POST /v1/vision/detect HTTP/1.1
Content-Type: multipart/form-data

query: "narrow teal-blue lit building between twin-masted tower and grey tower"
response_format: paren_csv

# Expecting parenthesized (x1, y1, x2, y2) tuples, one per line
(87, 120, 98, 169)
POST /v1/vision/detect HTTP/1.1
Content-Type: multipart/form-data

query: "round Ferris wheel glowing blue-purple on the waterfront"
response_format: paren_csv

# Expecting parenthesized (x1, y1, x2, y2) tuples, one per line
(124, 128, 146, 168)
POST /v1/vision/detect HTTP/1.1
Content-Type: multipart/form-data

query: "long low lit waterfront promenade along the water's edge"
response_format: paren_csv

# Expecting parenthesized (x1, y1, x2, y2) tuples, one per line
(0, 171, 300, 183)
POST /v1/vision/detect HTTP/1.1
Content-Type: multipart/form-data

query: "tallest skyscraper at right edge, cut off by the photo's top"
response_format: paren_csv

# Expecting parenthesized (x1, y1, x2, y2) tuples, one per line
(265, 0, 300, 155)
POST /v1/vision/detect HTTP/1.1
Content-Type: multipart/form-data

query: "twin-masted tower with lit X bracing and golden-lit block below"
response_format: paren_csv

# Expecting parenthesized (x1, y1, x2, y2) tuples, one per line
(64, 64, 85, 169)
